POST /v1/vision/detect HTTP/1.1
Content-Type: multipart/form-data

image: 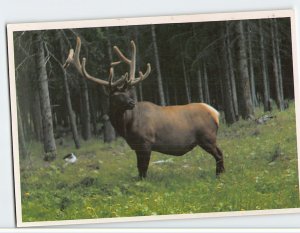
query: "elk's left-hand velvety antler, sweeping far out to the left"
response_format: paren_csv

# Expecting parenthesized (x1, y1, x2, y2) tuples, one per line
(63, 37, 126, 87)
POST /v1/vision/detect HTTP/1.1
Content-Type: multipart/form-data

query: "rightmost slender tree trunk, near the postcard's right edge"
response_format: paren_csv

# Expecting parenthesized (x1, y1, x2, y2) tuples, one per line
(271, 19, 284, 111)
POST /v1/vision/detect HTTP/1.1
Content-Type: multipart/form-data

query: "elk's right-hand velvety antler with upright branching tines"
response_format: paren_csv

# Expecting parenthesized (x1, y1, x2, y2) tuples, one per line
(111, 41, 151, 86)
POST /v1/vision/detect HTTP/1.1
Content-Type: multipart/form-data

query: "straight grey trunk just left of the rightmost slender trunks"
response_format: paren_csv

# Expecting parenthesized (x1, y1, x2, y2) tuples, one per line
(259, 20, 271, 112)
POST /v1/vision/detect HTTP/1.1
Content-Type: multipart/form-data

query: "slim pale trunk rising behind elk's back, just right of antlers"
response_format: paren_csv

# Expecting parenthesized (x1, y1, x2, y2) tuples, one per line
(151, 24, 166, 106)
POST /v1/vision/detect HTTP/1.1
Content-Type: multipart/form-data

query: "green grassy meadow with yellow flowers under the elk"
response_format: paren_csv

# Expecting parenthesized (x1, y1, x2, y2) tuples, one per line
(20, 104, 300, 222)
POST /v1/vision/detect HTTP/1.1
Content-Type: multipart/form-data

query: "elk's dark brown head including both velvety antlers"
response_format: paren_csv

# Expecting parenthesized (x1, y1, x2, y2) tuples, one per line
(63, 37, 151, 111)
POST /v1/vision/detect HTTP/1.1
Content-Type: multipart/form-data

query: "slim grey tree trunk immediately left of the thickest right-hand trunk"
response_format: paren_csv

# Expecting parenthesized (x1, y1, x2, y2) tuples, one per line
(226, 21, 239, 120)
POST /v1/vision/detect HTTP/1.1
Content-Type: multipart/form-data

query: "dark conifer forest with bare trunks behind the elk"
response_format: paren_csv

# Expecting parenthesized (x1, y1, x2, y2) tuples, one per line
(14, 18, 294, 160)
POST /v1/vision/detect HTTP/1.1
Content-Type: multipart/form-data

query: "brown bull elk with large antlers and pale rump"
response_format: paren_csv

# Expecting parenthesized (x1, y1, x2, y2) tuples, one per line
(64, 37, 224, 178)
